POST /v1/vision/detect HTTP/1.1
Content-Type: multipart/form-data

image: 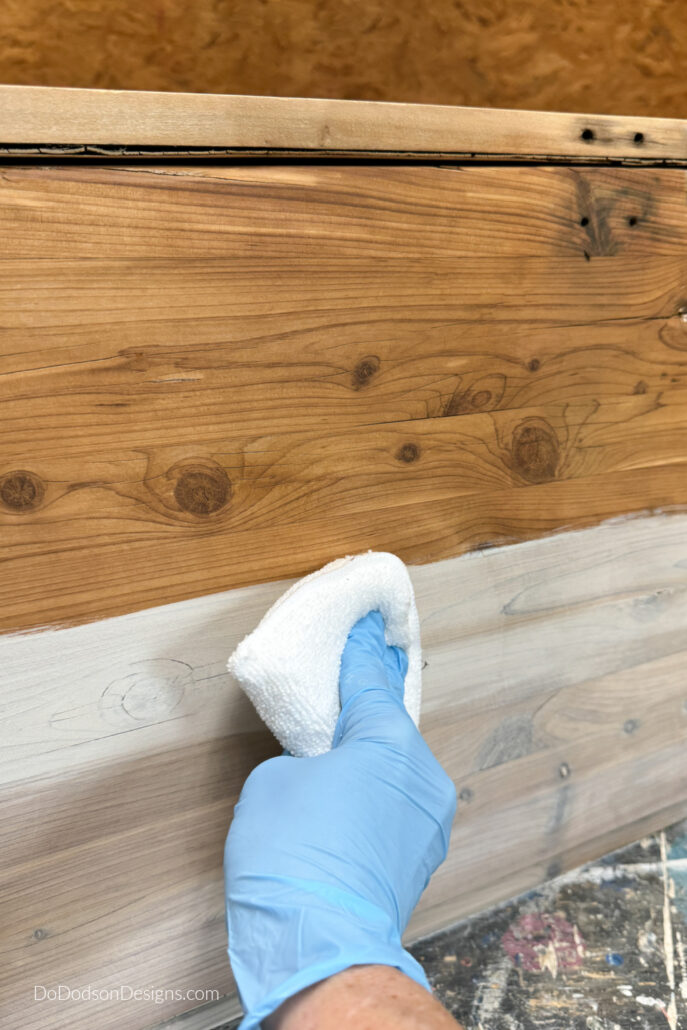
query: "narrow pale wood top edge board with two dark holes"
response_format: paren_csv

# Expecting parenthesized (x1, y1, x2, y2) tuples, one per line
(0, 85, 687, 164)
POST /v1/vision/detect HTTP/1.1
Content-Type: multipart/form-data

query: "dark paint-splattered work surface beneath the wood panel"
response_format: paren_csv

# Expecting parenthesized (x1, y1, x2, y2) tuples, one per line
(226, 821, 687, 1030)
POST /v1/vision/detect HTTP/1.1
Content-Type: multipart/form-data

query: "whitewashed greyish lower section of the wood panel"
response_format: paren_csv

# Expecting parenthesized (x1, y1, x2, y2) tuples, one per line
(0, 515, 687, 1030)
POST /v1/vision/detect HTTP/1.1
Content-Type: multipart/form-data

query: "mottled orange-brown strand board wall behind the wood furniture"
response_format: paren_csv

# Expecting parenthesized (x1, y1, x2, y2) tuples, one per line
(0, 0, 687, 117)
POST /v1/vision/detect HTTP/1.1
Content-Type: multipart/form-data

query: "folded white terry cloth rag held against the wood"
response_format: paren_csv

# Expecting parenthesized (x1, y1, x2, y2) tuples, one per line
(227, 551, 422, 758)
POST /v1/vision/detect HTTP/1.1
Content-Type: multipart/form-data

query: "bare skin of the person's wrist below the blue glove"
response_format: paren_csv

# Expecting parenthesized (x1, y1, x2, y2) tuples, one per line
(263, 965, 462, 1030)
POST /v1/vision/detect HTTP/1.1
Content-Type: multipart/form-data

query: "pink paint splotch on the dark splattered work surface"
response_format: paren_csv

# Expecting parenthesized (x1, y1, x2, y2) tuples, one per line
(501, 914, 584, 976)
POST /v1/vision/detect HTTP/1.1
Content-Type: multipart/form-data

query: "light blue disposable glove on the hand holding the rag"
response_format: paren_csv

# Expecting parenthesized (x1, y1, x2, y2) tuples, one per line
(225, 612, 455, 1030)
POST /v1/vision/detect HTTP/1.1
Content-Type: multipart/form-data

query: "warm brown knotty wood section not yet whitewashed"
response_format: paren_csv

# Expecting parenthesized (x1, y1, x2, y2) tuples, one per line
(0, 166, 687, 631)
